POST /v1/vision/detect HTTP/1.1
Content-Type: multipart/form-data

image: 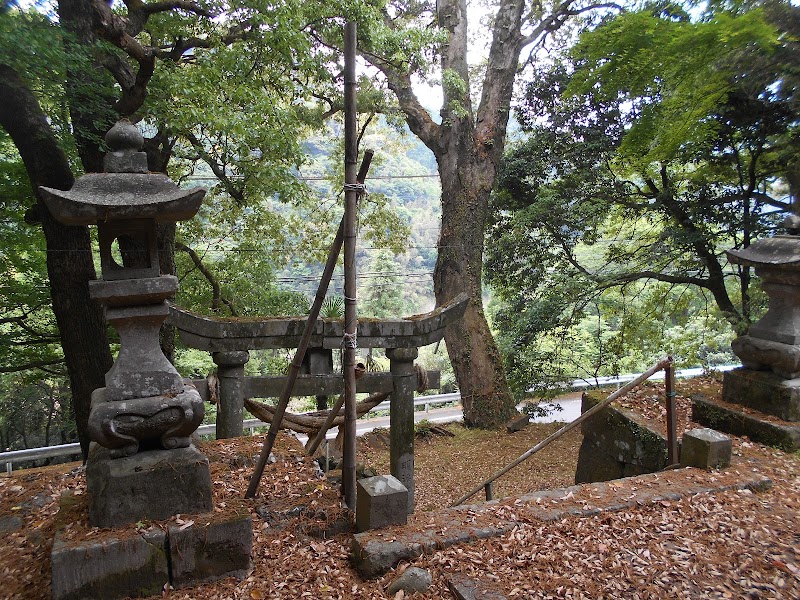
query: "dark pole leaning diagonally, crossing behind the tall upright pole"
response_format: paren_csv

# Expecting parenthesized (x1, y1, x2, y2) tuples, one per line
(245, 150, 374, 498)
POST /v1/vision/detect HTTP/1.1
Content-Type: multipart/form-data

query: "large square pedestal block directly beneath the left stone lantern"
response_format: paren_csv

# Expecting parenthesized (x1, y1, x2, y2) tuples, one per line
(86, 444, 213, 527)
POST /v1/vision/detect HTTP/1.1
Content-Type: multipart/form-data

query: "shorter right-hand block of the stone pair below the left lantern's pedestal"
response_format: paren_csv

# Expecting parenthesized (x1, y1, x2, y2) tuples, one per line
(169, 515, 253, 588)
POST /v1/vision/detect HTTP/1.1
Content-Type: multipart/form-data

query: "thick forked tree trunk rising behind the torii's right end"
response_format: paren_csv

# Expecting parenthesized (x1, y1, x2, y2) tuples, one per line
(433, 0, 522, 427)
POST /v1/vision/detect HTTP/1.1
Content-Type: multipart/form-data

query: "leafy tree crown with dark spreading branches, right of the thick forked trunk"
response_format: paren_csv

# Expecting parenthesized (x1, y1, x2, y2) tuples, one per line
(486, 2, 798, 393)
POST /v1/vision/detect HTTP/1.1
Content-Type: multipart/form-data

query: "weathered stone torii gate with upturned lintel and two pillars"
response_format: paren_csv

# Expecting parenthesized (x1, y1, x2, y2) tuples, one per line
(169, 294, 468, 512)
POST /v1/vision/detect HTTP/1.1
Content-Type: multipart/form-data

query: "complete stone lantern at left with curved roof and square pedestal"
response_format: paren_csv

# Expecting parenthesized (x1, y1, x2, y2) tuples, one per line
(40, 120, 212, 527)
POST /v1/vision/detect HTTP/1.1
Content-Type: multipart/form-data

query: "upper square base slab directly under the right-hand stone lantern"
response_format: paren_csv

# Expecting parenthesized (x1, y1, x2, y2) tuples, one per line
(722, 368, 800, 421)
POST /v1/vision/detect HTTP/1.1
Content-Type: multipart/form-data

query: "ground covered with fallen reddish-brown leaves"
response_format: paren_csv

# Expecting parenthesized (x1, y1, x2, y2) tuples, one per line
(0, 378, 800, 600)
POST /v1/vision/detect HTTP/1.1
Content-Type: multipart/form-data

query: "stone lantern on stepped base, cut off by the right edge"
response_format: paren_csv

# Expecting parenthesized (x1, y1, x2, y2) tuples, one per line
(693, 215, 800, 450)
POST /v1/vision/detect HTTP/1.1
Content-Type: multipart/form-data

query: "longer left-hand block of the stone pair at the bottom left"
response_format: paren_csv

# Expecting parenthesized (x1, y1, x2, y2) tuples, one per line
(50, 528, 169, 600)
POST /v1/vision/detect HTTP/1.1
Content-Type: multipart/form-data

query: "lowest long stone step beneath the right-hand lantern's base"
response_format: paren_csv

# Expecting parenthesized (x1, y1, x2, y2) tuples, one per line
(692, 394, 800, 452)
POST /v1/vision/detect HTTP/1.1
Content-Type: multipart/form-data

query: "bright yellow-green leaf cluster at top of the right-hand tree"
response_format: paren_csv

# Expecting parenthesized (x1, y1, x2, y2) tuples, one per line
(566, 6, 779, 169)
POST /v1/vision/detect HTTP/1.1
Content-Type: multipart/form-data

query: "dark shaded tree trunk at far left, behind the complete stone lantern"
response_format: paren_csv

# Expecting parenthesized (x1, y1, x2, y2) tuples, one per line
(0, 65, 112, 456)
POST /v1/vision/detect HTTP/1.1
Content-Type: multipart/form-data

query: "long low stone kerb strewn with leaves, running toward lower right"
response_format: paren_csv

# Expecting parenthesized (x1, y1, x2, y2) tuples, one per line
(351, 467, 772, 578)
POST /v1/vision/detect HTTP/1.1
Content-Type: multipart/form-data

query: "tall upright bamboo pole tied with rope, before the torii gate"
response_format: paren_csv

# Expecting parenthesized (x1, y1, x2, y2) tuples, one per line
(342, 22, 358, 510)
